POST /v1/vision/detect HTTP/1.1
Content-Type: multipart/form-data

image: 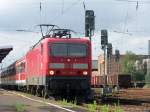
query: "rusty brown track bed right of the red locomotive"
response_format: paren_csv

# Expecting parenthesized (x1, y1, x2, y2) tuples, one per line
(90, 88, 150, 106)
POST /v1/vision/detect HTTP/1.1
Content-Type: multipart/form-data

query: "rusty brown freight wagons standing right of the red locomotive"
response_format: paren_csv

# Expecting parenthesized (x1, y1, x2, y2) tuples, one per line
(91, 74, 132, 88)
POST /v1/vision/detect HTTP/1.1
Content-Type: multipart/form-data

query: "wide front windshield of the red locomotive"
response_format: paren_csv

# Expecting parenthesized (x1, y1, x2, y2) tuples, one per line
(50, 43, 87, 57)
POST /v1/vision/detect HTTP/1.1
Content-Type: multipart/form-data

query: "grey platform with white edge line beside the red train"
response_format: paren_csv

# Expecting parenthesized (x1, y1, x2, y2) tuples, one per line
(0, 89, 75, 112)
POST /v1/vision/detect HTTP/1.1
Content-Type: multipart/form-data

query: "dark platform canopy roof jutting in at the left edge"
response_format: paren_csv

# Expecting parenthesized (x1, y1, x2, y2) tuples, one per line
(0, 46, 13, 63)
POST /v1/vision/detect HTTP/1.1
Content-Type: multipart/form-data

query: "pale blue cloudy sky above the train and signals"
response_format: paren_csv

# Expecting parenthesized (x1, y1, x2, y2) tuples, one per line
(0, 0, 150, 66)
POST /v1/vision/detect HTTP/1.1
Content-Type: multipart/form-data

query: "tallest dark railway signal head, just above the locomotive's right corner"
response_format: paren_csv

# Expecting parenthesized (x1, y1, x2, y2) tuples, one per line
(85, 10, 95, 40)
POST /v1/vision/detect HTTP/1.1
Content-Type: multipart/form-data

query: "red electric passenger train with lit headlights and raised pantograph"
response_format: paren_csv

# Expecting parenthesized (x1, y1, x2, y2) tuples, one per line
(0, 25, 92, 100)
